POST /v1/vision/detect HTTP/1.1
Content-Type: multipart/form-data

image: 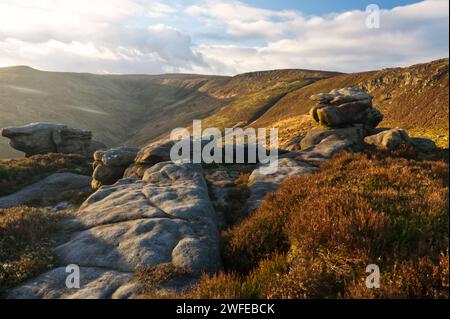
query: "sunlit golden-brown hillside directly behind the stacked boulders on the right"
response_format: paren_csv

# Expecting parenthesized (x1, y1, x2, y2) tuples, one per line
(251, 59, 449, 147)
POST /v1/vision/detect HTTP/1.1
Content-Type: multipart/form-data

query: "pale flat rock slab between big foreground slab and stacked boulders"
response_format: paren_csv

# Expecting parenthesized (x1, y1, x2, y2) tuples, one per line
(248, 158, 319, 210)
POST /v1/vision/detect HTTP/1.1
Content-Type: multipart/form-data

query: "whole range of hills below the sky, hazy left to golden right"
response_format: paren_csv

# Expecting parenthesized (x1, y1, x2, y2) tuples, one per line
(0, 59, 448, 157)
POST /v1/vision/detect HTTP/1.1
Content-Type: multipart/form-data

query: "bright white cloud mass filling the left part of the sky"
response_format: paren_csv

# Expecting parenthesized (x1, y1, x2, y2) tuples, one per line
(0, 0, 203, 73)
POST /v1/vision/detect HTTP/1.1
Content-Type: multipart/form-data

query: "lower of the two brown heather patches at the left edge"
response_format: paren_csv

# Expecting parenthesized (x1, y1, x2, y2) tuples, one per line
(0, 206, 60, 292)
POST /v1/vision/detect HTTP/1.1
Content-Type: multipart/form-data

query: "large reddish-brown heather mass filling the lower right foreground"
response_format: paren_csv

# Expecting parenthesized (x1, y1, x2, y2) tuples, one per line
(224, 153, 449, 298)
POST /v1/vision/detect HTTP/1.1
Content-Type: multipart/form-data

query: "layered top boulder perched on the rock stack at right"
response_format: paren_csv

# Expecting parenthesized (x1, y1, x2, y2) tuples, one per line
(310, 88, 383, 128)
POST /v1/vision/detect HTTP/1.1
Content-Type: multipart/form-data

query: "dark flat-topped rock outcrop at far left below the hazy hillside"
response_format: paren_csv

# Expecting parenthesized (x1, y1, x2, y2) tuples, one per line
(1, 123, 104, 157)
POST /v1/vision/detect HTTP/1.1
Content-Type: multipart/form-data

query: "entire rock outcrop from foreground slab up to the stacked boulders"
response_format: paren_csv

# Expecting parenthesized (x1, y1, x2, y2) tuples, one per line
(5, 88, 442, 298)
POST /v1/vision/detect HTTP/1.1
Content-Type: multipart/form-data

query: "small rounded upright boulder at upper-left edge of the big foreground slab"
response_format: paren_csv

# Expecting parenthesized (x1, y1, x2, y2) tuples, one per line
(92, 147, 139, 189)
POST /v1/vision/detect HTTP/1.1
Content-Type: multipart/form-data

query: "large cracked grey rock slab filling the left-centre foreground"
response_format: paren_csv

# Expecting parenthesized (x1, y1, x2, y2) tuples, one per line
(9, 162, 220, 298)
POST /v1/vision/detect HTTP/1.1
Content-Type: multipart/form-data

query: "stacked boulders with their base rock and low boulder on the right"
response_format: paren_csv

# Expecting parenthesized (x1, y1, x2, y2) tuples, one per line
(292, 87, 437, 163)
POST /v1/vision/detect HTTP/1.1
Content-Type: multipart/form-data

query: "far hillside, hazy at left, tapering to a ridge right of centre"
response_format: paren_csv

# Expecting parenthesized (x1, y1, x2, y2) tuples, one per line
(0, 66, 333, 157)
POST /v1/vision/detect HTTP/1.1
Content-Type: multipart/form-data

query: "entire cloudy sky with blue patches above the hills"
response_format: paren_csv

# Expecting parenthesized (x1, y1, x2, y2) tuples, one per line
(0, 0, 449, 75)
